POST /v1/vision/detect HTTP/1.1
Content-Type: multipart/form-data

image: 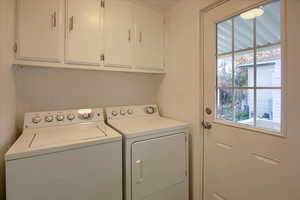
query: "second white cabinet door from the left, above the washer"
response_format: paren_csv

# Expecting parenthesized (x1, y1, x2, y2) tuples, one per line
(65, 0, 102, 65)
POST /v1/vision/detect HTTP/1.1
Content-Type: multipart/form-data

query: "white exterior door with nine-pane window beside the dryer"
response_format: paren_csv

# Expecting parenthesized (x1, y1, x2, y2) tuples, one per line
(202, 0, 300, 200)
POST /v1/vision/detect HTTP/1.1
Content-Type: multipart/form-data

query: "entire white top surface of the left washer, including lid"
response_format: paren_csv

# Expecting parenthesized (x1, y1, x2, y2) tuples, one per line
(5, 122, 122, 161)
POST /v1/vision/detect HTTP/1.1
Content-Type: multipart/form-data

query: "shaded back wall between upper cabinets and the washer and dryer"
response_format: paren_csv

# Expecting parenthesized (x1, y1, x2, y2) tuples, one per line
(15, 67, 164, 128)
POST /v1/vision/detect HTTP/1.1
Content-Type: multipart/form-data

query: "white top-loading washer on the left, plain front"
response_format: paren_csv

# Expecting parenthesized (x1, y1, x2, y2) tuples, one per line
(5, 108, 122, 200)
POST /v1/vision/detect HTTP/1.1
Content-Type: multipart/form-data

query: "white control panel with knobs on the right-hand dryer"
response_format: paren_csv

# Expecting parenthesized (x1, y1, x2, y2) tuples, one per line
(105, 105, 159, 120)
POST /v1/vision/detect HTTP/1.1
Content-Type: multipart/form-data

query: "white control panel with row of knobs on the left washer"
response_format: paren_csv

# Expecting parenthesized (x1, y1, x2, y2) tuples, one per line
(24, 108, 104, 129)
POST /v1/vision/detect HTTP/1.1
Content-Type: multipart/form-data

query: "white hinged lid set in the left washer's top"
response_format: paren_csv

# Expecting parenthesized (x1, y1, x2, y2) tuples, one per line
(29, 124, 106, 148)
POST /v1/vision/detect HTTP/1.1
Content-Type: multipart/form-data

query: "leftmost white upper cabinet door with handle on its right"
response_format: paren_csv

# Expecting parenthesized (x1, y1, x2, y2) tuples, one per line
(16, 0, 63, 62)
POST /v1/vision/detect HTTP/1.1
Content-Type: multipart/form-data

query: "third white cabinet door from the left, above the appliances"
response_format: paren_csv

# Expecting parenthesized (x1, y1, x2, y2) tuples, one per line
(104, 0, 134, 67)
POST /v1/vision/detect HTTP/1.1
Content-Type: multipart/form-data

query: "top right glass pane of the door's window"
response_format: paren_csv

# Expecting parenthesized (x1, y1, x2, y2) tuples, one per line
(256, 0, 280, 46)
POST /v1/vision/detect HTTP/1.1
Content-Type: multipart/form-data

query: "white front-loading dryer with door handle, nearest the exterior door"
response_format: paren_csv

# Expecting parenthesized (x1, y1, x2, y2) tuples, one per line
(106, 105, 189, 200)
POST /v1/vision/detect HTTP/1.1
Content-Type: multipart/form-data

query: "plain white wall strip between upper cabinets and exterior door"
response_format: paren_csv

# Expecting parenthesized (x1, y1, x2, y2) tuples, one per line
(158, 0, 214, 200)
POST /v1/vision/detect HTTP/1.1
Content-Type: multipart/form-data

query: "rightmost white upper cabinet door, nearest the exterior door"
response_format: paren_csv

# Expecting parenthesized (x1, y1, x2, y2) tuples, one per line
(135, 6, 164, 69)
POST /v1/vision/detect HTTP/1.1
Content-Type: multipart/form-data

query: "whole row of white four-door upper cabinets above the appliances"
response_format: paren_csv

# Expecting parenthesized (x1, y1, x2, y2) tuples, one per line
(16, 0, 164, 73)
